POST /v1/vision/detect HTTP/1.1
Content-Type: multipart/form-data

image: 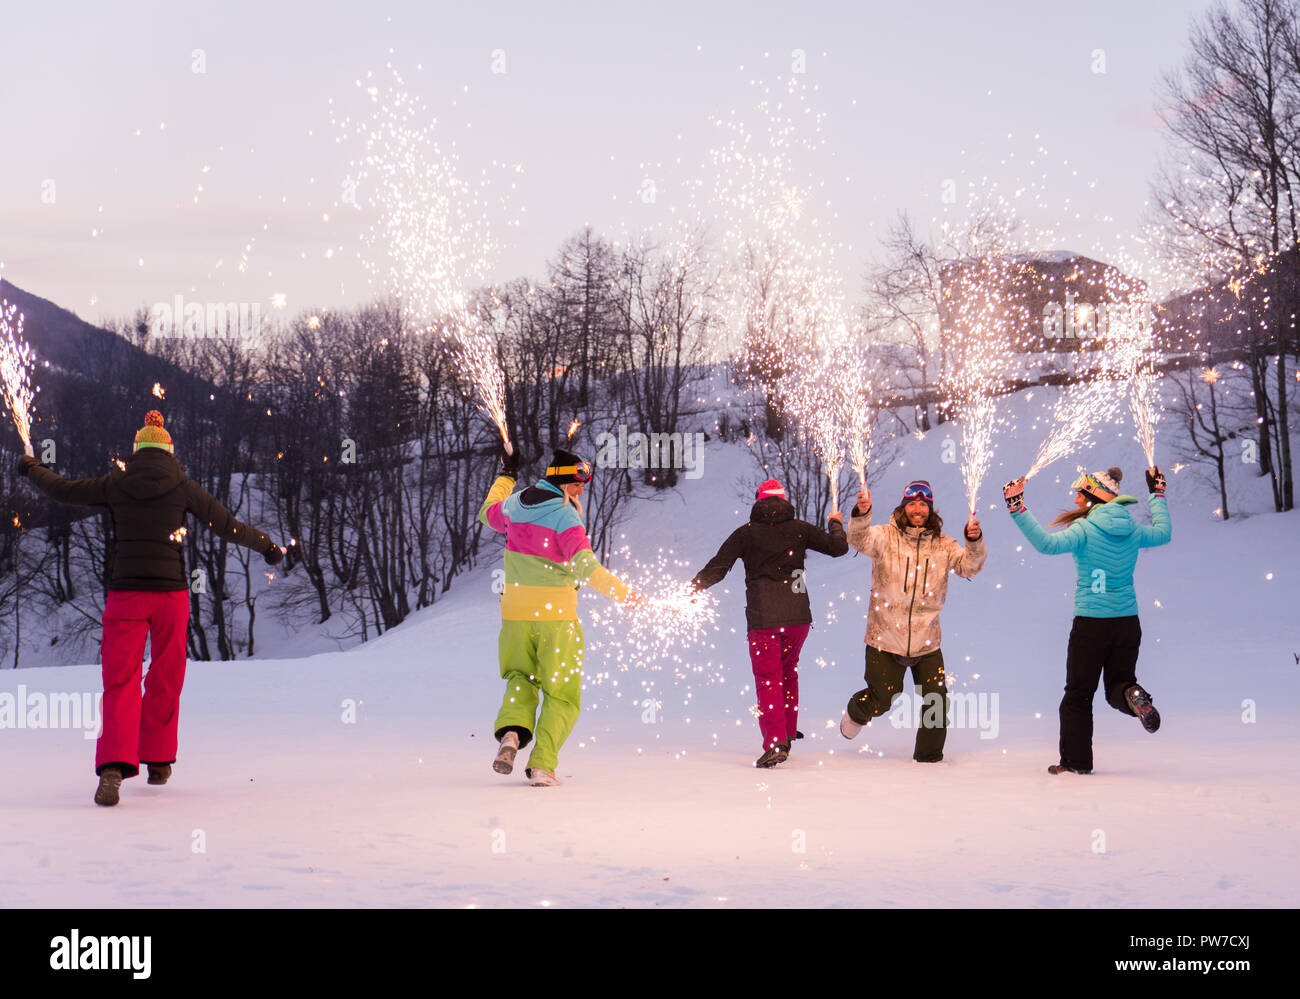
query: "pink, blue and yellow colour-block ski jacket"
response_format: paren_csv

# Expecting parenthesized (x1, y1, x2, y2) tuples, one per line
(478, 475, 628, 620)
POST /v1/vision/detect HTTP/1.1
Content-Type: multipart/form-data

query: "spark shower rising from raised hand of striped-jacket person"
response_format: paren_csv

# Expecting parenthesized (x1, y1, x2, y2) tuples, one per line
(335, 65, 511, 450)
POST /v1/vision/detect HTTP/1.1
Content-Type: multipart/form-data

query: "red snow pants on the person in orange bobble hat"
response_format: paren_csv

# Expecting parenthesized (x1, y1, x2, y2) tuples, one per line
(95, 589, 190, 777)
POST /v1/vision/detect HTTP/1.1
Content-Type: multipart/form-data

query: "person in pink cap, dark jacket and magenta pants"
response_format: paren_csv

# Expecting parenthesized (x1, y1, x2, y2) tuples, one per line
(692, 479, 849, 767)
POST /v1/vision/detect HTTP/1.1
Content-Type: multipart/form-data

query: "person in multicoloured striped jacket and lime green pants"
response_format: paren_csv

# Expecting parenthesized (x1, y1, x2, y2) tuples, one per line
(478, 450, 642, 787)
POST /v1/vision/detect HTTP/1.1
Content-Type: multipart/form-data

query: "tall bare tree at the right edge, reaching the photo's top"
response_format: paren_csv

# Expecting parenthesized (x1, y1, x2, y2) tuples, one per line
(1154, 0, 1300, 511)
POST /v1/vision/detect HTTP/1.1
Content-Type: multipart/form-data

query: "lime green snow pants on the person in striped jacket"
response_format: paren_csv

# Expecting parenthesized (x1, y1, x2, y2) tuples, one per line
(495, 620, 586, 773)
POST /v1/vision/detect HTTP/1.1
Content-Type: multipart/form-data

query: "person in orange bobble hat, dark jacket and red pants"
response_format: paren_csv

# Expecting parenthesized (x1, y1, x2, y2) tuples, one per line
(18, 410, 285, 805)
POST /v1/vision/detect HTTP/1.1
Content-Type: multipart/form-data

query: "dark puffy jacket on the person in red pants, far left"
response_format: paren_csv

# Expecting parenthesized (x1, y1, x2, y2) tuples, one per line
(27, 447, 272, 591)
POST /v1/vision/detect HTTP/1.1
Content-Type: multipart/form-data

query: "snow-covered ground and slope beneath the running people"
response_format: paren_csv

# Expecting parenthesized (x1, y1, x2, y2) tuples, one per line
(0, 393, 1300, 907)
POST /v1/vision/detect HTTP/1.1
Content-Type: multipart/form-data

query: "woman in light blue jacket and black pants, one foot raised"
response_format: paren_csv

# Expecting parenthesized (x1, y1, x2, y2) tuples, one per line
(1002, 466, 1171, 774)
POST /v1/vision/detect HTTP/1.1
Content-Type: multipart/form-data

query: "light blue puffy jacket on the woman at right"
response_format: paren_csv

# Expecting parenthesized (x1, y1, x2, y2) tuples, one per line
(1011, 496, 1173, 618)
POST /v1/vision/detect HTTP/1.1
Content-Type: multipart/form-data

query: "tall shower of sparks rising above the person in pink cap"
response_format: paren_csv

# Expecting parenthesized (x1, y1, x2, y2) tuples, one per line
(707, 78, 875, 510)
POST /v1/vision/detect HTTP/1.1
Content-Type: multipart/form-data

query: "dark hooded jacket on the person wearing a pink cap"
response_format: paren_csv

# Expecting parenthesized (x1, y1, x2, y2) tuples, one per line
(692, 496, 849, 631)
